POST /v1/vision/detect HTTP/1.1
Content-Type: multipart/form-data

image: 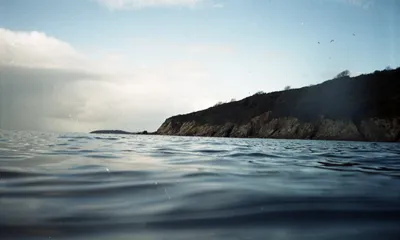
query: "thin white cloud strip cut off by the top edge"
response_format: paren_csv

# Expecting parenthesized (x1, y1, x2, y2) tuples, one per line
(96, 0, 204, 10)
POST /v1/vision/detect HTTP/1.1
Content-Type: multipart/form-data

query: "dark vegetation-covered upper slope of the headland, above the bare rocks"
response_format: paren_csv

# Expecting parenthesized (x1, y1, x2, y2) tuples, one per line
(167, 68, 400, 124)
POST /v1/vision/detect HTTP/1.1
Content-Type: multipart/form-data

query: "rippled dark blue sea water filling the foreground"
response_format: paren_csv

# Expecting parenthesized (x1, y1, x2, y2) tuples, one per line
(0, 131, 400, 240)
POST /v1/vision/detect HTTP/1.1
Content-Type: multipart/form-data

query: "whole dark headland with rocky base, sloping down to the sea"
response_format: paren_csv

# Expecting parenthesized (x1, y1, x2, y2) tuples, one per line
(156, 68, 400, 142)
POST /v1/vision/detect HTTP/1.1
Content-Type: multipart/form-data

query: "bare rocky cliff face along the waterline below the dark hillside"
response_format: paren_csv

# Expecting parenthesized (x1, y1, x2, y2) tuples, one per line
(156, 115, 400, 142)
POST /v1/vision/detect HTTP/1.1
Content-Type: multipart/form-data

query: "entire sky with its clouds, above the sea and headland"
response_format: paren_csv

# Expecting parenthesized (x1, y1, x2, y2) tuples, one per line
(0, 0, 400, 132)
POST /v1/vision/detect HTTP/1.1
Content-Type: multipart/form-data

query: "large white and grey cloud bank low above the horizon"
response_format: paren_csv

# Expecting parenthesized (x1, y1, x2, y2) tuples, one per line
(0, 29, 214, 131)
